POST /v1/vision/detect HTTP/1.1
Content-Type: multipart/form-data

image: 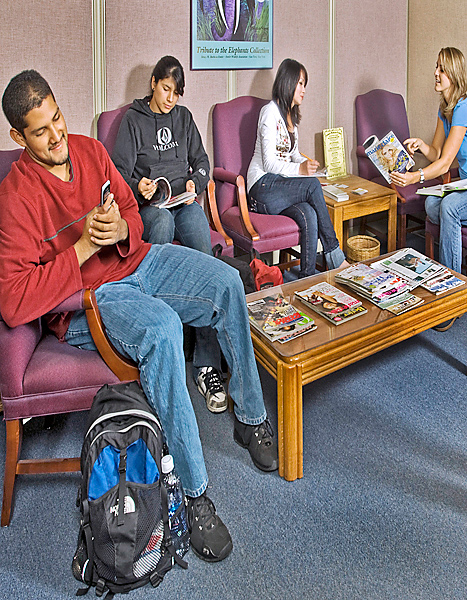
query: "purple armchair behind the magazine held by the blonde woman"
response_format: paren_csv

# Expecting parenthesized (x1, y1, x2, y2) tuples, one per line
(355, 90, 439, 248)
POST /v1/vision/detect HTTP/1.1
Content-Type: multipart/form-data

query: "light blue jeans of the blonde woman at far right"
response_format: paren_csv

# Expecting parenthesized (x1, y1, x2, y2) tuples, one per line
(425, 192, 467, 273)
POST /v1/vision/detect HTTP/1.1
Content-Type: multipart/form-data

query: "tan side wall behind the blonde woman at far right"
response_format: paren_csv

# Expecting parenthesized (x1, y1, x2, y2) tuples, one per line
(408, 0, 467, 164)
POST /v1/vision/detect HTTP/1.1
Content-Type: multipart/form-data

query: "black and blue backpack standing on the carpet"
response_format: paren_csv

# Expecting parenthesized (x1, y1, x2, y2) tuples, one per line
(72, 381, 189, 600)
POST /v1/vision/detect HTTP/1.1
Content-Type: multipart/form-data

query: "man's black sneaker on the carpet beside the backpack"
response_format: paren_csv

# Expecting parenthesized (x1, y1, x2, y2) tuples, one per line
(186, 492, 233, 562)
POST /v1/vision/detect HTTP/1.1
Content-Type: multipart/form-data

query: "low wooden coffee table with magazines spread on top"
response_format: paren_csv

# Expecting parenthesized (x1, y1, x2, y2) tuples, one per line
(247, 255, 467, 481)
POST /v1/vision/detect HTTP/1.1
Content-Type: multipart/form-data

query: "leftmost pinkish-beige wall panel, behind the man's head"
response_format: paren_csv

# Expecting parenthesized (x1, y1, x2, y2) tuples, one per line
(0, 0, 93, 149)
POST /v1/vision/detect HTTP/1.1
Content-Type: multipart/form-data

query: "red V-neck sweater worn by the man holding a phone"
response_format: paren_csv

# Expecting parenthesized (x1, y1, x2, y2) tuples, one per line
(0, 135, 150, 338)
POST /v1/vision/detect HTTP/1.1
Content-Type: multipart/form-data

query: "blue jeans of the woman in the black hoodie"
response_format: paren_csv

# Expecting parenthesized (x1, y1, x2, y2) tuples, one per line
(139, 201, 221, 379)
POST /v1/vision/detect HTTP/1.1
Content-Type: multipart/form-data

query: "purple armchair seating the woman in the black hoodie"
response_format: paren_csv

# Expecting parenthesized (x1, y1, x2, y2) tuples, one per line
(97, 104, 233, 256)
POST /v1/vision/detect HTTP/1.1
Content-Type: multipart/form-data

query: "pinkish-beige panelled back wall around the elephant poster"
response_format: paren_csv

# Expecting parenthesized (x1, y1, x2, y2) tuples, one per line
(0, 0, 414, 176)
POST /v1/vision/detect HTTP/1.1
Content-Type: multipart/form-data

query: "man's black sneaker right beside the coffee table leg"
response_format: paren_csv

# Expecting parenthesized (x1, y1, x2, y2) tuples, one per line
(234, 419, 279, 471)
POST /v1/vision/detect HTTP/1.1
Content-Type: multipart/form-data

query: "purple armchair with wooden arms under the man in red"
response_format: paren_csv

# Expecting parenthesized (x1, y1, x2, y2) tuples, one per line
(0, 150, 139, 527)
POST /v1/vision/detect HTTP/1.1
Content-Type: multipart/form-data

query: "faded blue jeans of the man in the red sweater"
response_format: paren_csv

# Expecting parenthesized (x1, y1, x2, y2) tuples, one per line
(66, 244, 266, 496)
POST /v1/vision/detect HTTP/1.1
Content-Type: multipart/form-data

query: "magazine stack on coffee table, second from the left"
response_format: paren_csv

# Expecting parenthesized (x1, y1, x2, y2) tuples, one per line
(295, 281, 367, 325)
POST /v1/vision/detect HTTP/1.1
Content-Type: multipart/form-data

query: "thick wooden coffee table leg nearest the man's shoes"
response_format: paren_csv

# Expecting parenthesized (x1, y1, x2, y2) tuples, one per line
(277, 363, 303, 481)
